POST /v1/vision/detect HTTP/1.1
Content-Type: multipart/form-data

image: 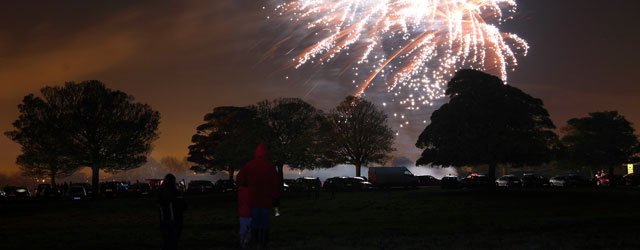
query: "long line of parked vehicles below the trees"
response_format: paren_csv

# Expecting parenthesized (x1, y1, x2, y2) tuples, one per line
(0, 171, 640, 201)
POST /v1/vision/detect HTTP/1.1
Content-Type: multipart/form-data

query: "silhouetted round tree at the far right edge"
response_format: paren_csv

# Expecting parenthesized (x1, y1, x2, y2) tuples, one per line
(562, 111, 640, 180)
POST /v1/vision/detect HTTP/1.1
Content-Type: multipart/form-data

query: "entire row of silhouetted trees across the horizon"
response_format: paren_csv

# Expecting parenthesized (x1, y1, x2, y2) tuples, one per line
(5, 70, 640, 192)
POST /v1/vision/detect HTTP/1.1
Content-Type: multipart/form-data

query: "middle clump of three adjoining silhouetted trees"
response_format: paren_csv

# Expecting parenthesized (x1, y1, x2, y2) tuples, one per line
(188, 96, 394, 183)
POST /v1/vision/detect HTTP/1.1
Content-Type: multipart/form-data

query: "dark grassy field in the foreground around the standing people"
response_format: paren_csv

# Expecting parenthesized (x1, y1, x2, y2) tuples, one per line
(0, 188, 640, 250)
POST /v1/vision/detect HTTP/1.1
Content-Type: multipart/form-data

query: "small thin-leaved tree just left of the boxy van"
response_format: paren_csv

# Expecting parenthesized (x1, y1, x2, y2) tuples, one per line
(329, 96, 395, 176)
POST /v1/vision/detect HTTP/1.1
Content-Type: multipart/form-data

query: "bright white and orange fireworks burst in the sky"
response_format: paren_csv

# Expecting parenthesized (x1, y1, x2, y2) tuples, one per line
(268, 0, 528, 114)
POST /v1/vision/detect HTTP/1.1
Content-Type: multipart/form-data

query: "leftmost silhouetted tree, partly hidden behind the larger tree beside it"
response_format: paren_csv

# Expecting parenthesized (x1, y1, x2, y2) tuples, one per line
(5, 95, 79, 185)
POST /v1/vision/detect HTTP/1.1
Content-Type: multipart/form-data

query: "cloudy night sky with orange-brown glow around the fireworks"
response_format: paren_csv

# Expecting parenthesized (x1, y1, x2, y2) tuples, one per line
(0, 0, 640, 173)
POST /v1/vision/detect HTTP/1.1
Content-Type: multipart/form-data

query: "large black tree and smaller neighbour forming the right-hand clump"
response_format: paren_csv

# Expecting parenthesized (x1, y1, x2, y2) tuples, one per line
(416, 70, 640, 182)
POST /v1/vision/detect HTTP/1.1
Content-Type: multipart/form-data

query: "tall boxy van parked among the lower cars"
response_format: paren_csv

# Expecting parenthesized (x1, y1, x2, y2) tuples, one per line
(369, 167, 418, 188)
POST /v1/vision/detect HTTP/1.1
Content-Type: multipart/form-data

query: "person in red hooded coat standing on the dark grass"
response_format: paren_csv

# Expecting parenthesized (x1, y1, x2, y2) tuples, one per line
(236, 144, 280, 247)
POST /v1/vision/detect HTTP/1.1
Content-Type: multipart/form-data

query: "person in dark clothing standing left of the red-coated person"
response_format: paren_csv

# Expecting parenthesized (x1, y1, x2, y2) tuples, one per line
(158, 174, 187, 250)
